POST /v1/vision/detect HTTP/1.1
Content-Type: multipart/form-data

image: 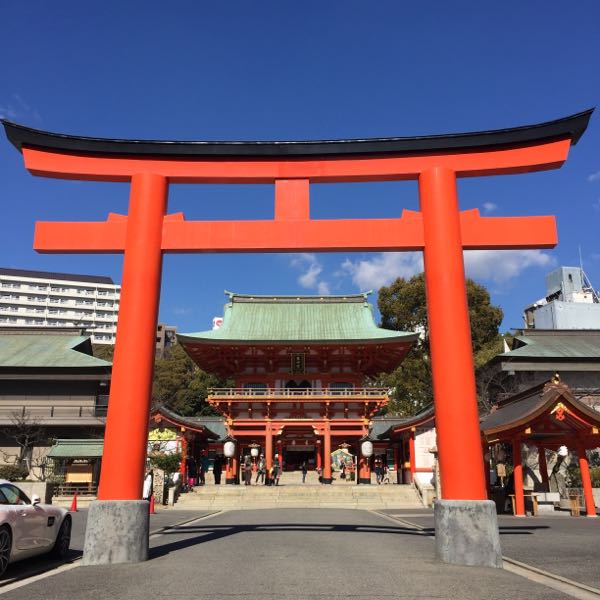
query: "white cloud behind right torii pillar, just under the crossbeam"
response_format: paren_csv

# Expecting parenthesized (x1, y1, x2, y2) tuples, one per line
(342, 250, 555, 291)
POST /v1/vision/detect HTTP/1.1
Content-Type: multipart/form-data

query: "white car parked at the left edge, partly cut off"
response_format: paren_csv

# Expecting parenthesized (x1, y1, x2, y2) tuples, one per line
(0, 479, 71, 577)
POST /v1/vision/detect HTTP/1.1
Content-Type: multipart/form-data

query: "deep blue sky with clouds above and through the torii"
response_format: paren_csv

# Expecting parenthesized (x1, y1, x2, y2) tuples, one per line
(0, 0, 600, 331)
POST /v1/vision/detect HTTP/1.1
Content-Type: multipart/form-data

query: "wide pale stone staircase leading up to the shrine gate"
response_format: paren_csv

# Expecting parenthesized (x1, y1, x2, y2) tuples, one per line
(173, 473, 423, 510)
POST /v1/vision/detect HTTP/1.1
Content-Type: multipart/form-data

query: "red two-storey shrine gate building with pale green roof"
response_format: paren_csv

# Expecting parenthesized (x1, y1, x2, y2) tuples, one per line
(162, 292, 418, 483)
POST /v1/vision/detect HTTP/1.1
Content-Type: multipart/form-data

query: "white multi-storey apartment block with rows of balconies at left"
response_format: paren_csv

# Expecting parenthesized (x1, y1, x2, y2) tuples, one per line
(0, 268, 121, 344)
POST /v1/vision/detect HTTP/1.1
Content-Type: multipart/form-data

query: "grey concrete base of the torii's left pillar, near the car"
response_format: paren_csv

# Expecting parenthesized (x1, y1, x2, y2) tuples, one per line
(82, 500, 150, 565)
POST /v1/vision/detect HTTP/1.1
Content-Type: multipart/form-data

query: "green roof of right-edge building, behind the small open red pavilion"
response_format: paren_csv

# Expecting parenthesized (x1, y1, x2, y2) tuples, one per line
(500, 329, 600, 360)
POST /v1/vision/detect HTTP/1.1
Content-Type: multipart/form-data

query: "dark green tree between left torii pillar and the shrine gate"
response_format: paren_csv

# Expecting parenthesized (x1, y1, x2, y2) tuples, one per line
(152, 344, 227, 416)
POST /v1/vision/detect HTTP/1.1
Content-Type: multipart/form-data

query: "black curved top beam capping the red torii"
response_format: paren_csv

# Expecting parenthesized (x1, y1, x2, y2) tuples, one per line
(2, 109, 594, 158)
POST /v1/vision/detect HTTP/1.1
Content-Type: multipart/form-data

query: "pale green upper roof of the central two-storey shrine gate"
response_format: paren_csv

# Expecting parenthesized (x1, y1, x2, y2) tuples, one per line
(178, 292, 418, 343)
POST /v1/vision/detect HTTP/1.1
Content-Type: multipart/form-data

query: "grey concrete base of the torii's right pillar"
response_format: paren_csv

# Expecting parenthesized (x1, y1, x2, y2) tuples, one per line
(434, 500, 502, 568)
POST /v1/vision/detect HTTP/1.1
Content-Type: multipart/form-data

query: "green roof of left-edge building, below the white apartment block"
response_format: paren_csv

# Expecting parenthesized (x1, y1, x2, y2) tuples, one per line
(0, 332, 111, 369)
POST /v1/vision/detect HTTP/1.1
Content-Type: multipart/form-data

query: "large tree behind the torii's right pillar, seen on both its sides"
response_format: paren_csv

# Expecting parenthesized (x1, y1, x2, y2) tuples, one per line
(378, 273, 503, 416)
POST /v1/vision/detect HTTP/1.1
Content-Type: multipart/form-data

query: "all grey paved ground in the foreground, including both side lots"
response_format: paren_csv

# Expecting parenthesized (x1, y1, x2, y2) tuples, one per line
(0, 509, 600, 600)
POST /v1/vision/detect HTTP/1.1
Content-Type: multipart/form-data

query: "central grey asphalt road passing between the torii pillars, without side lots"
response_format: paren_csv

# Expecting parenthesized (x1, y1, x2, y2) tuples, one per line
(0, 509, 566, 600)
